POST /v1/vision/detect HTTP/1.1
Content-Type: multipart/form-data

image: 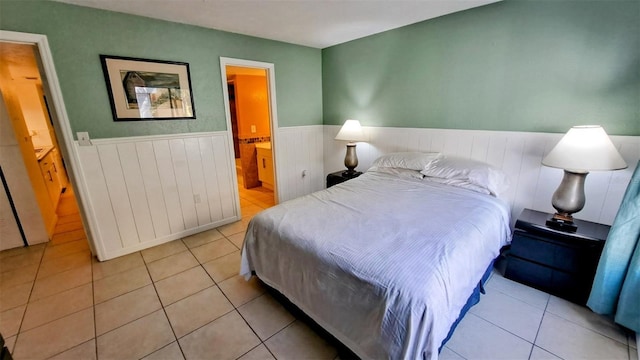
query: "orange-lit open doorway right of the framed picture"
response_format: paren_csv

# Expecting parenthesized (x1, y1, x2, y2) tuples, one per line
(221, 59, 277, 217)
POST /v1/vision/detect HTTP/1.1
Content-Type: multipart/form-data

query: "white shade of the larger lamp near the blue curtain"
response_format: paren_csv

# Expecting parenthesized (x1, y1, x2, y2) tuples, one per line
(542, 125, 627, 173)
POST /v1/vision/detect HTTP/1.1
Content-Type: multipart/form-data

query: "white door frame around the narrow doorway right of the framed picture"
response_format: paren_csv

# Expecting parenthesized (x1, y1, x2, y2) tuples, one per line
(220, 56, 280, 214)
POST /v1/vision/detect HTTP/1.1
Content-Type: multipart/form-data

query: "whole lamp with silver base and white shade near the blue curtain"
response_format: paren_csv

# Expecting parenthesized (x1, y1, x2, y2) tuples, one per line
(542, 125, 627, 232)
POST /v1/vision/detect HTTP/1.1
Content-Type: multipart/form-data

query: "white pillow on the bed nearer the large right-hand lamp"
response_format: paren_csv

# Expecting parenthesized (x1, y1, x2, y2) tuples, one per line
(421, 156, 509, 197)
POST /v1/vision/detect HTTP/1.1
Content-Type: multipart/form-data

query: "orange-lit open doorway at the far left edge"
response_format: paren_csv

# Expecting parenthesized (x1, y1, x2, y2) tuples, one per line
(0, 41, 88, 250)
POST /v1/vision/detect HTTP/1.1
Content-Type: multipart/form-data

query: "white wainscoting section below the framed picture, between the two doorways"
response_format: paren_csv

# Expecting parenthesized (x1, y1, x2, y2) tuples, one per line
(75, 132, 240, 260)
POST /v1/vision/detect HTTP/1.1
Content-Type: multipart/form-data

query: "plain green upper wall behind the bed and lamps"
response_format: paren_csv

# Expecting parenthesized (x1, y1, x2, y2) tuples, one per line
(322, 0, 640, 135)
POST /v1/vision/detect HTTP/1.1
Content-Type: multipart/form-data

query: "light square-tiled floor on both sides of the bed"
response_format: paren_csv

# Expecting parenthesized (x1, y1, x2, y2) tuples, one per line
(0, 184, 637, 360)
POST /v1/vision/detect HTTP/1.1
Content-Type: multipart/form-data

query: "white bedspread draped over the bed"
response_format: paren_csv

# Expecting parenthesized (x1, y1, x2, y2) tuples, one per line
(240, 172, 510, 359)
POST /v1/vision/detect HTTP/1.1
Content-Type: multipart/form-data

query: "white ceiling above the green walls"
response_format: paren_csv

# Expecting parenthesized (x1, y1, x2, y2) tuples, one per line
(54, 0, 500, 49)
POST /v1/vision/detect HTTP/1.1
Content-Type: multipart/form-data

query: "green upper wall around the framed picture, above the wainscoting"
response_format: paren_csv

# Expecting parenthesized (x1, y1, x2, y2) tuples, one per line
(0, 0, 322, 138)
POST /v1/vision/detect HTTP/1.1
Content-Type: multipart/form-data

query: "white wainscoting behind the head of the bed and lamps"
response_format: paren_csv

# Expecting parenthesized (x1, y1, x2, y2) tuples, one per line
(324, 125, 640, 224)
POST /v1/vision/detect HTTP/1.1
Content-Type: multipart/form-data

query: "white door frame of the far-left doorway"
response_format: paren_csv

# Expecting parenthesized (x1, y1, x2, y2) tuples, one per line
(0, 30, 104, 259)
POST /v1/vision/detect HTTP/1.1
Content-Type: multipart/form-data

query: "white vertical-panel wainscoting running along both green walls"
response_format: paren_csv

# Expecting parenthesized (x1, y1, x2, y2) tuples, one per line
(69, 125, 640, 260)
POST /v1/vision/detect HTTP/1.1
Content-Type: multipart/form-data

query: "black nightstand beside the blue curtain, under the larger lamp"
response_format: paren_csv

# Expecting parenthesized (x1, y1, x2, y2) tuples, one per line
(505, 209, 610, 305)
